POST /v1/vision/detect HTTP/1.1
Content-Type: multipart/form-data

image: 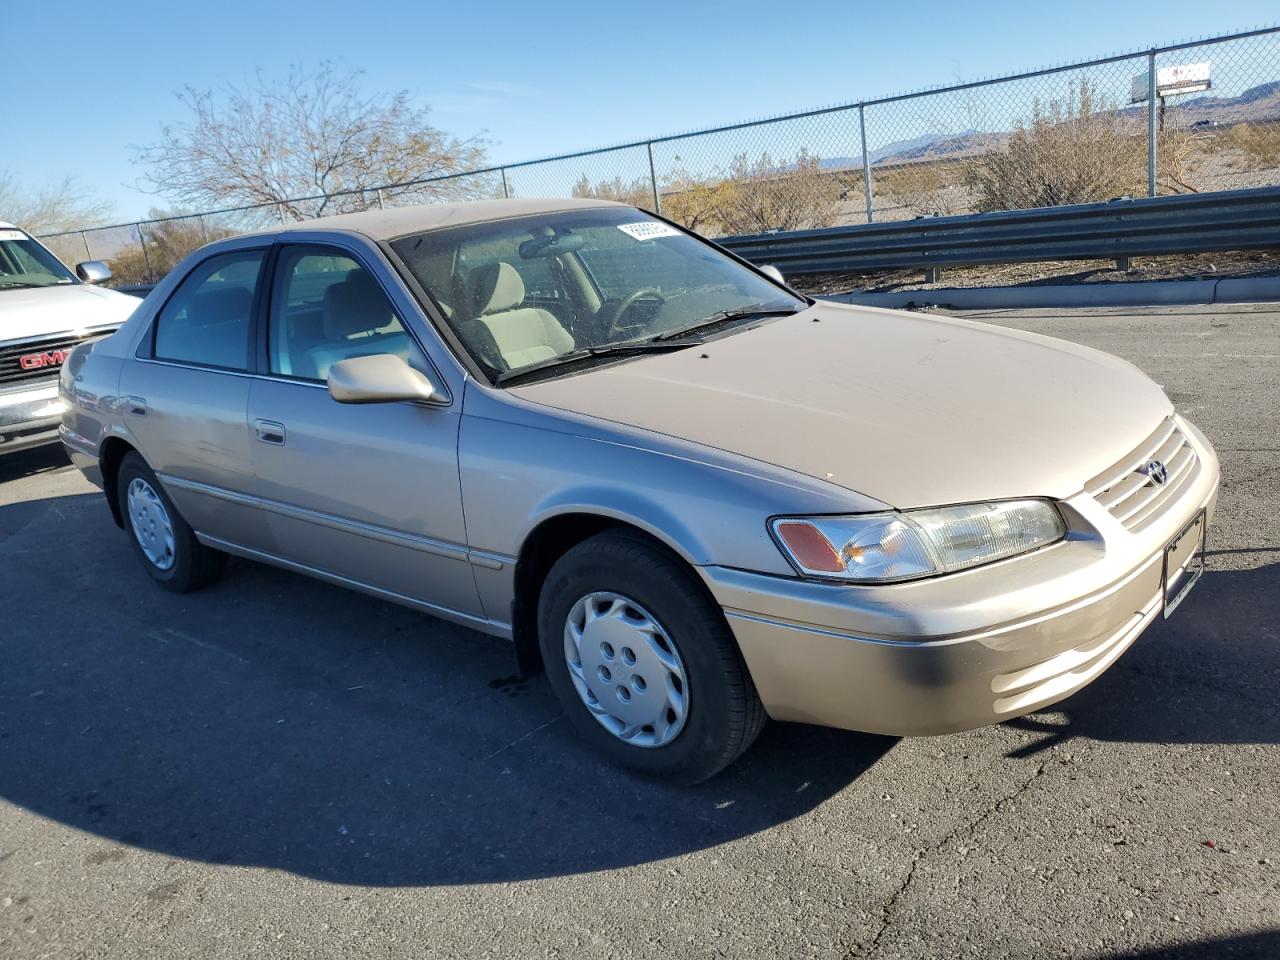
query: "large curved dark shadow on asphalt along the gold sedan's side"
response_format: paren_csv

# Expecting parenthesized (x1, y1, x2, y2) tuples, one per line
(0, 494, 896, 886)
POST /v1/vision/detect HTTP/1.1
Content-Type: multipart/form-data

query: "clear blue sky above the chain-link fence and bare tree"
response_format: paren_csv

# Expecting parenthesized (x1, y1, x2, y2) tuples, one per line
(0, 0, 1280, 220)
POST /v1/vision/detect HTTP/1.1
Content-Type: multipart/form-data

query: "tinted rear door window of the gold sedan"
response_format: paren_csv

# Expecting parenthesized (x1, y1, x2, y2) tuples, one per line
(154, 250, 266, 370)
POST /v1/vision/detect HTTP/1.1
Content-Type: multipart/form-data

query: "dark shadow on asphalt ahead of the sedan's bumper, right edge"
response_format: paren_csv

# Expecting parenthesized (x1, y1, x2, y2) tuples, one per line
(1009, 563, 1280, 756)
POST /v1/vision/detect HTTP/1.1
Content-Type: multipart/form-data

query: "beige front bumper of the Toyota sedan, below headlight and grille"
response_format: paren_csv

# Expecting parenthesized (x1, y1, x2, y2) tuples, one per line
(700, 417, 1219, 736)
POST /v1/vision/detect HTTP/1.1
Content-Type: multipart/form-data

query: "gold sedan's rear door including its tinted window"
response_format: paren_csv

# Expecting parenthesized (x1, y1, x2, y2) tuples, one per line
(120, 247, 270, 549)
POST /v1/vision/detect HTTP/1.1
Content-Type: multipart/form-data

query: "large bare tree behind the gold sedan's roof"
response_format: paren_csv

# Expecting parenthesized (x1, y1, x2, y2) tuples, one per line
(134, 61, 494, 220)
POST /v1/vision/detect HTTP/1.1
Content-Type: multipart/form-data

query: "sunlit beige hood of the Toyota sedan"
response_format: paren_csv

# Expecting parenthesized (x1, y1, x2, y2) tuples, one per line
(512, 303, 1172, 508)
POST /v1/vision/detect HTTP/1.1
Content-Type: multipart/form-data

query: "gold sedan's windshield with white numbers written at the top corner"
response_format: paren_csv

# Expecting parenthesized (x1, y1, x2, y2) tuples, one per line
(392, 206, 805, 380)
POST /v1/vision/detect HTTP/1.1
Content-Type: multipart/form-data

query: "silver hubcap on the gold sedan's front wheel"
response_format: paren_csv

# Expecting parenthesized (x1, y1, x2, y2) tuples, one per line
(564, 593, 689, 748)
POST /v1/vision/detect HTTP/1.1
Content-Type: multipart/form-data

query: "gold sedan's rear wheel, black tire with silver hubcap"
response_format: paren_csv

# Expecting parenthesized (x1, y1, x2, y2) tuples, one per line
(115, 453, 227, 594)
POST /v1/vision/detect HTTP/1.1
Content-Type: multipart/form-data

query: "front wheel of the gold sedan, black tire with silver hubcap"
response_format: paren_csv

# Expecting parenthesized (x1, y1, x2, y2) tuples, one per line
(538, 531, 765, 783)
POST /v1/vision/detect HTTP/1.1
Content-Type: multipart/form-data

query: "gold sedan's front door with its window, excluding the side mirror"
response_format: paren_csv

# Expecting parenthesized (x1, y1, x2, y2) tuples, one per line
(240, 244, 481, 616)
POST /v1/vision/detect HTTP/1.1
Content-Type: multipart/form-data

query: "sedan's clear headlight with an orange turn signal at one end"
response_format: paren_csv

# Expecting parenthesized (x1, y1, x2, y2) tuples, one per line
(771, 500, 1066, 584)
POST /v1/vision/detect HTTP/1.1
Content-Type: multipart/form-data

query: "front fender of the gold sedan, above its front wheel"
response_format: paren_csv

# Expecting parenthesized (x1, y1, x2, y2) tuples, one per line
(458, 393, 883, 576)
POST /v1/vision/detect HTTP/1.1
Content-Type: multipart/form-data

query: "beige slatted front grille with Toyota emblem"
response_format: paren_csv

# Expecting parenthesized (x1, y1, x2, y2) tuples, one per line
(1084, 417, 1201, 532)
